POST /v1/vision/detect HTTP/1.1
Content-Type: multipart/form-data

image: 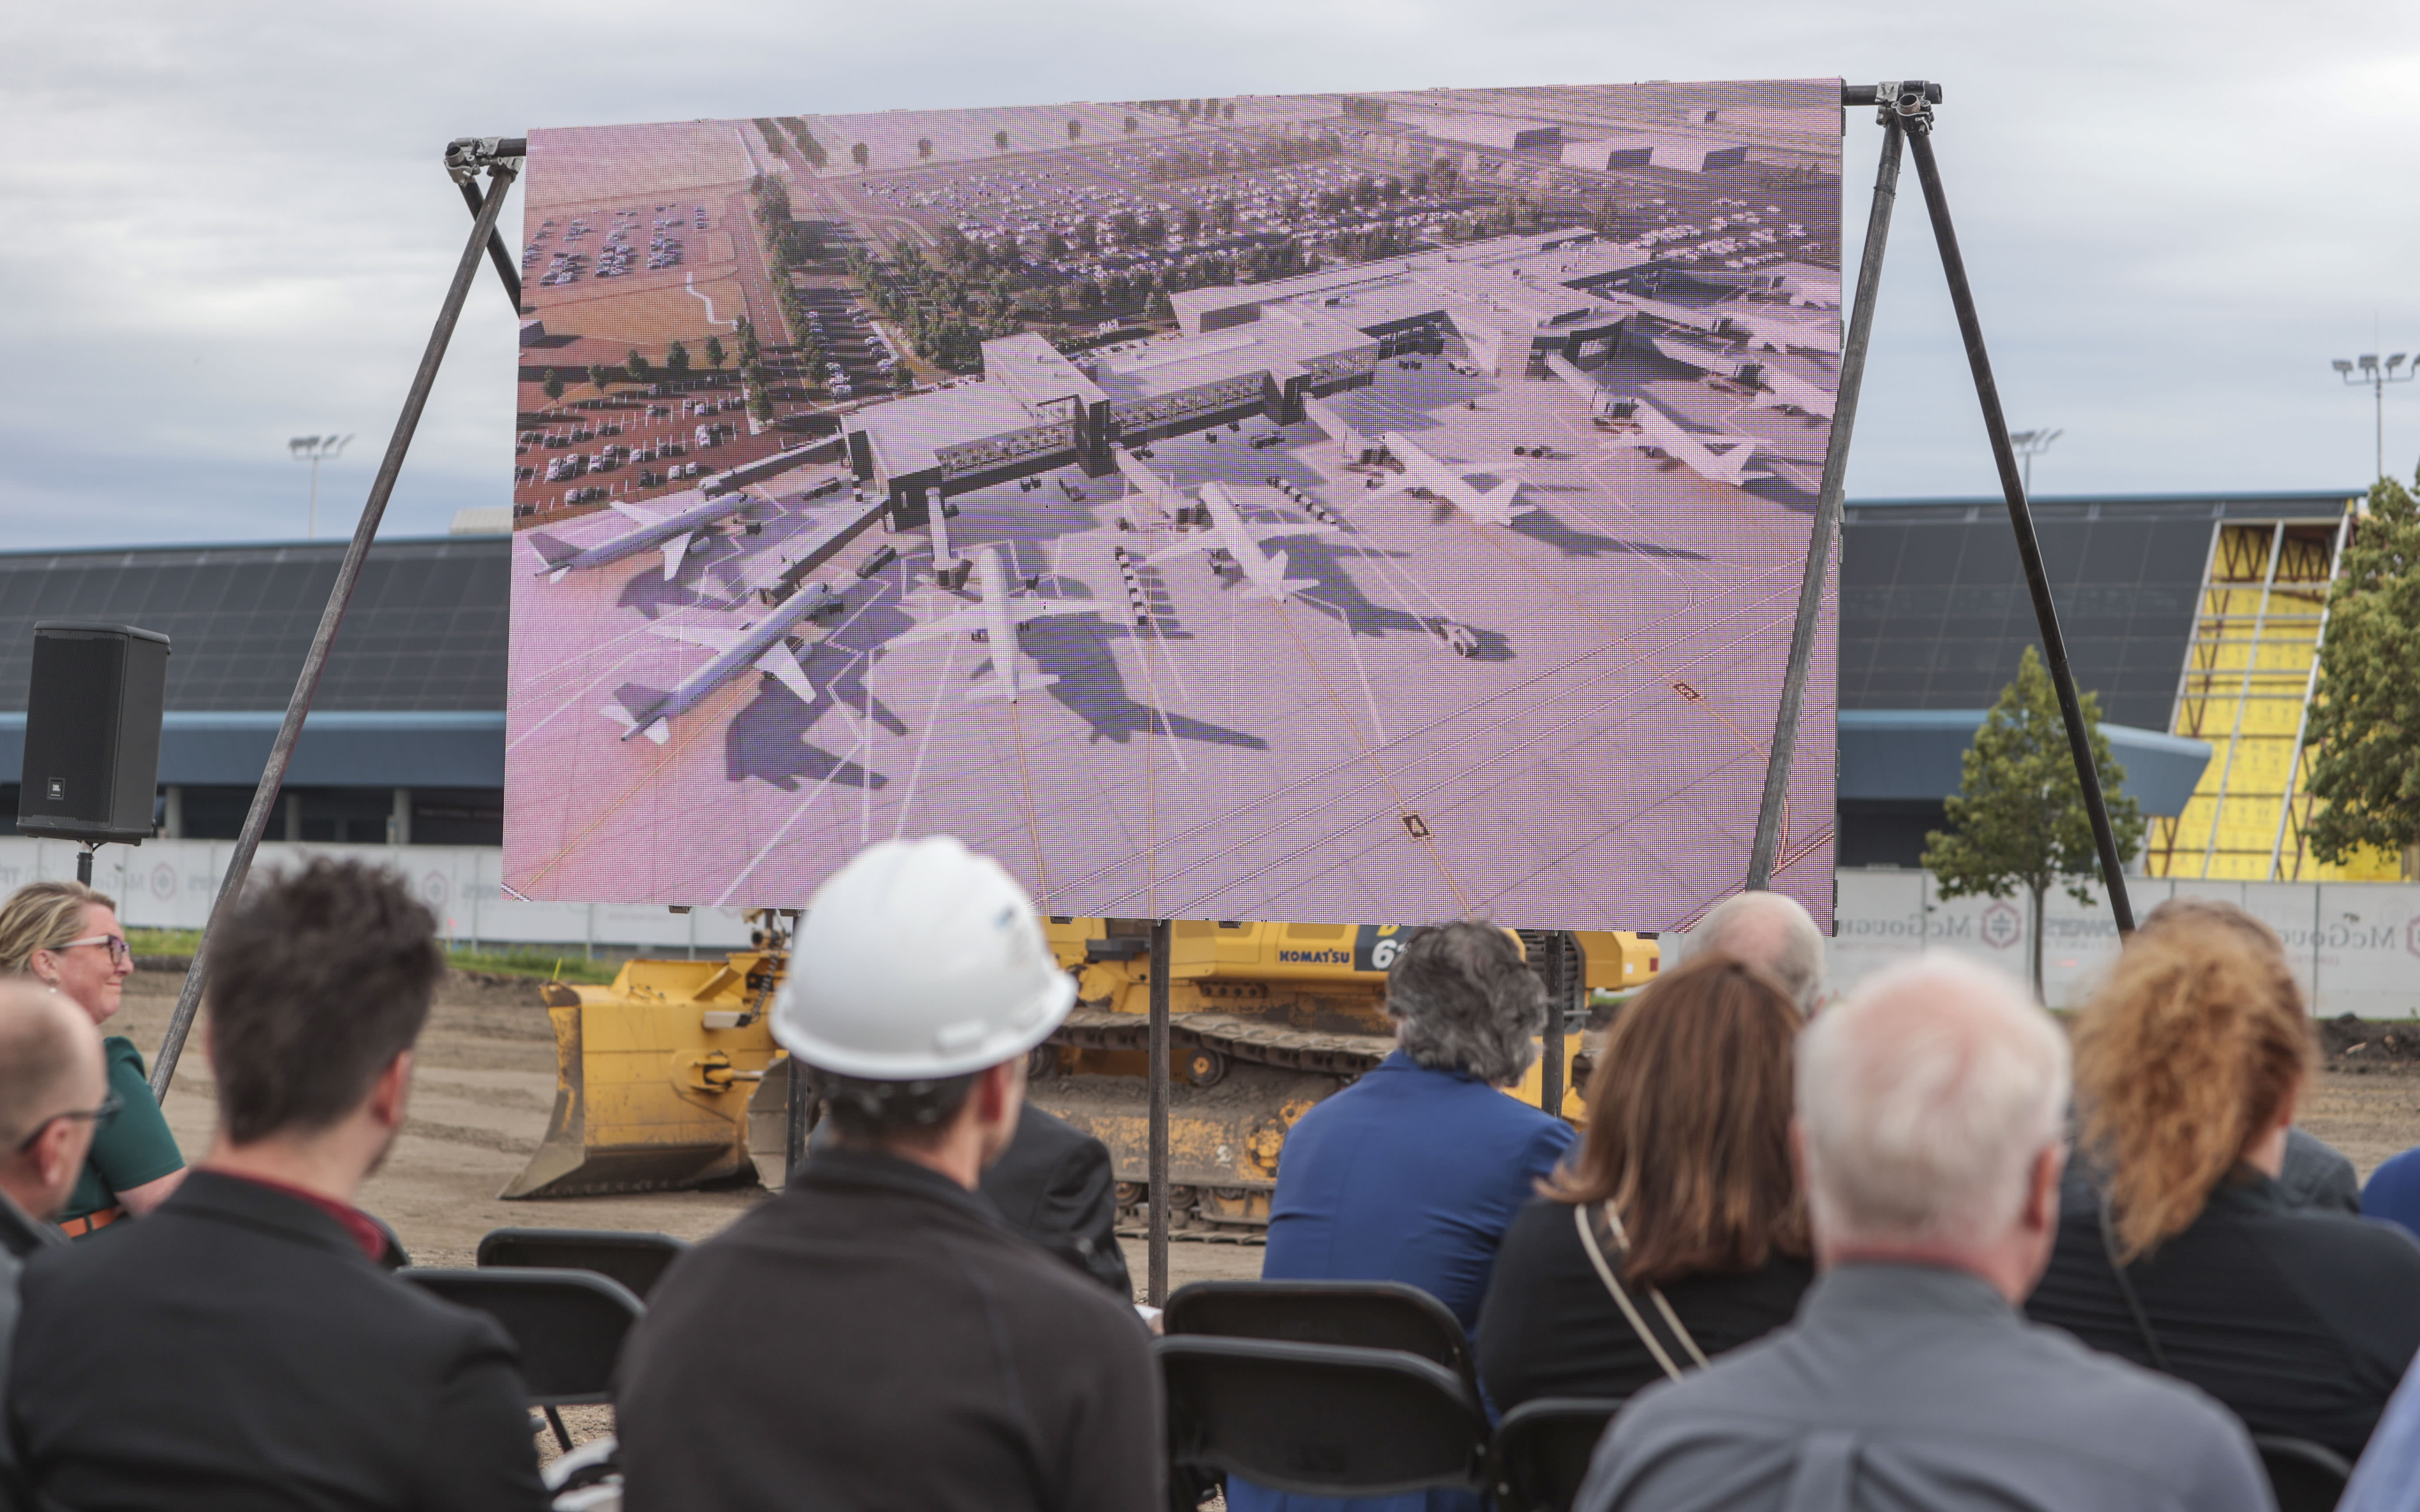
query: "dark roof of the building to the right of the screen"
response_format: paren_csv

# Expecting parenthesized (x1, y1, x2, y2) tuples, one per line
(1839, 491, 2355, 731)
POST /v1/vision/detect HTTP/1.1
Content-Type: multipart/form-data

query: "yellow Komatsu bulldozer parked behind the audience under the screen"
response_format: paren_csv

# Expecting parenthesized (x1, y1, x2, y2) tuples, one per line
(501, 912, 1660, 1229)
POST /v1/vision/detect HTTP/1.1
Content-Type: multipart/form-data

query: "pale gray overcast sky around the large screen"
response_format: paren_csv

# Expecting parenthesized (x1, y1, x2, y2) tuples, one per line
(0, 0, 2420, 549)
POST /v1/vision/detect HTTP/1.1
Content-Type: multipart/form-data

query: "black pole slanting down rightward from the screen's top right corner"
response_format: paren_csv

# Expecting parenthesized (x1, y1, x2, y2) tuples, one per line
(1892, 94, 2134, 934)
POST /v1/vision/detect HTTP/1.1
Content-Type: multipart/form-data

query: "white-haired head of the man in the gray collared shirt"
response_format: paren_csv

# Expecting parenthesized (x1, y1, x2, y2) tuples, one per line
(1798, 951, 2069, 1246)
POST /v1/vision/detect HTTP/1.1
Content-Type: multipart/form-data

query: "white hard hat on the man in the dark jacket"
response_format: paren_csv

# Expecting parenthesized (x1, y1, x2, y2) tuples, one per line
(772, 835, 1075, 1081)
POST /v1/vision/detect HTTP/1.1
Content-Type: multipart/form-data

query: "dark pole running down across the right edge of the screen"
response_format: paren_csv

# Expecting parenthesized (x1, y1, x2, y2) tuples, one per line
(1747, 100, 1922, 893)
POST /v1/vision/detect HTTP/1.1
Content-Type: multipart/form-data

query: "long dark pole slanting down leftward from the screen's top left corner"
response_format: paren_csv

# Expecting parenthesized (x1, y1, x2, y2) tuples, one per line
(150, 143, 520, 1098)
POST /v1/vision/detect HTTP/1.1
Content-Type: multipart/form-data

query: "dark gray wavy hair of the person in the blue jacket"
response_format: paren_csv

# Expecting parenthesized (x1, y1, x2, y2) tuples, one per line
(1386, 919, 1547, 1086)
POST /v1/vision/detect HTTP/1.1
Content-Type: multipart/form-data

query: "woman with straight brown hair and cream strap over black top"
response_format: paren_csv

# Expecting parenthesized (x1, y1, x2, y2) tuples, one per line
(1478, 953, 1815, 1413)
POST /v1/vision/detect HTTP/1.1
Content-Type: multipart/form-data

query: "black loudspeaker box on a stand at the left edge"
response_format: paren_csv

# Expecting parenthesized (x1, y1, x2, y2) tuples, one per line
(17, 619, 167, 844)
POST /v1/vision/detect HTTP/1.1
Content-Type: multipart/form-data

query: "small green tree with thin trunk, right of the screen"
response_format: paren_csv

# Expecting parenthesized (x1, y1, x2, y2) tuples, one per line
(1924, 646, 2142, 997)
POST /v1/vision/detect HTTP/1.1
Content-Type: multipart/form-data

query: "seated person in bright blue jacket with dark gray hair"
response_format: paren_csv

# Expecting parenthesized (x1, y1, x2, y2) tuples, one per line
(1227, 919, 1573, 1512)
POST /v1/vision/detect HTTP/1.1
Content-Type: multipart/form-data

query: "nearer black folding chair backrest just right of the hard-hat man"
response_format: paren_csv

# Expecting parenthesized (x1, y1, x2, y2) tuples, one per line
(1159, 1336, 1488, 1495)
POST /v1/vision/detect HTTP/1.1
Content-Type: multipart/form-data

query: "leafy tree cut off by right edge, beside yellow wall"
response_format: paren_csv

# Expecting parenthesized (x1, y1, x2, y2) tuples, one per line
(2304, 479, 2420, 876)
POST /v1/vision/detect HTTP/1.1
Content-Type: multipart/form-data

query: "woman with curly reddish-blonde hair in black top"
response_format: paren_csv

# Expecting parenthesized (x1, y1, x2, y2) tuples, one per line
(2026, 919, 2420, 1459)
